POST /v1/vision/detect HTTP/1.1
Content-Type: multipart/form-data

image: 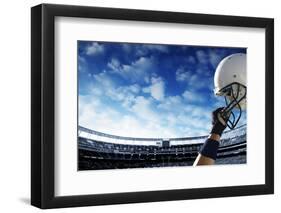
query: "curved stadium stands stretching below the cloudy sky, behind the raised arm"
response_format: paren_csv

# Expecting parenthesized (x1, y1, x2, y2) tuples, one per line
(78, 125, 247, 170)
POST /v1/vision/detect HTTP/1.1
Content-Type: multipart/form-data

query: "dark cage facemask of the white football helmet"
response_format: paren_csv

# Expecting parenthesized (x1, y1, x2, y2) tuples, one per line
(219, 82, 247, 129)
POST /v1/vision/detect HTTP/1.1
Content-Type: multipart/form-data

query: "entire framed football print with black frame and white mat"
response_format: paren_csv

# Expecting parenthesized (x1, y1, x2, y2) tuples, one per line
(31, 4, 274, 208)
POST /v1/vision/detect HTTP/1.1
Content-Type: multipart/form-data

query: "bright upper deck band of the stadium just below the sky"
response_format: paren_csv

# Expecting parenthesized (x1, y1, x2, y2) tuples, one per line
(78, 124, 247, 146)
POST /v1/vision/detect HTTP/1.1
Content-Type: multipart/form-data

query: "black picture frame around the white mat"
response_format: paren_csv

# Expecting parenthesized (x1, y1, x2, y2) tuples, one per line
(31, 4, 274, 209)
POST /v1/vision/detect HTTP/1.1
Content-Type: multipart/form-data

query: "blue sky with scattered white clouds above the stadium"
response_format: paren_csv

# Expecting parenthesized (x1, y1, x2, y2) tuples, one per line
(78, 41, 246, 138)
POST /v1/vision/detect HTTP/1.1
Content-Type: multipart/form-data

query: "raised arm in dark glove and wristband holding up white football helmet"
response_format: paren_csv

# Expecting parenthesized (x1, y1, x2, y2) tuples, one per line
(193, 53, 247, 166)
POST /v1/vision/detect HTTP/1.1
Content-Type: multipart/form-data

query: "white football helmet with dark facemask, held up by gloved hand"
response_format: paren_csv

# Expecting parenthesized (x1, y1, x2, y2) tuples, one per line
(214, 53, 247, 129)
